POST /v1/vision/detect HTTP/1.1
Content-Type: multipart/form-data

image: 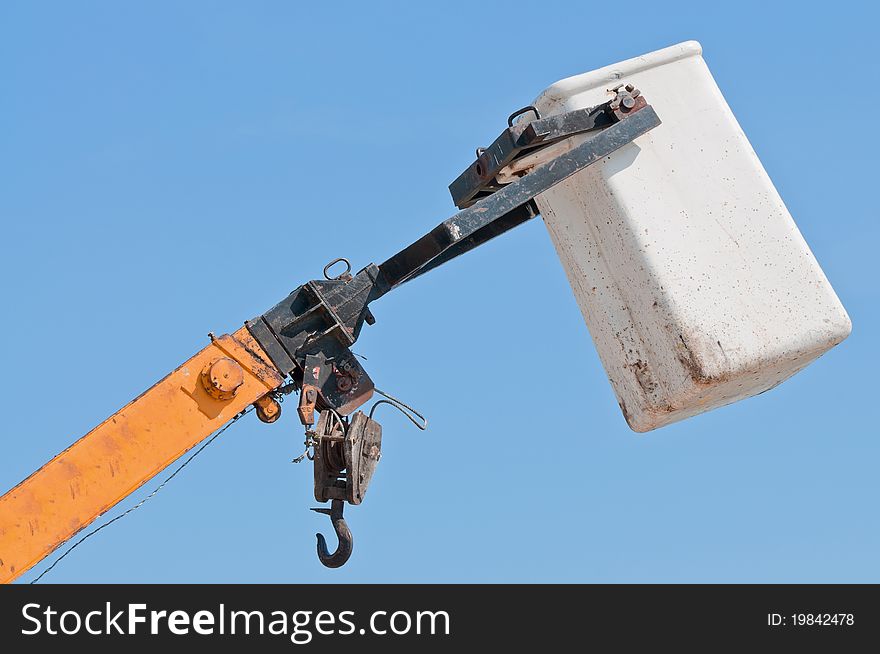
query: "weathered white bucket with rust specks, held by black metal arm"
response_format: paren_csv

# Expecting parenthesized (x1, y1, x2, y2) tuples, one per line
(534, 41, 851, 431)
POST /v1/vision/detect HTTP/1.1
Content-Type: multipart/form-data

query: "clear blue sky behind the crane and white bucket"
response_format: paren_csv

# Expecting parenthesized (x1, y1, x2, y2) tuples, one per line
(0, 1, 880, 582)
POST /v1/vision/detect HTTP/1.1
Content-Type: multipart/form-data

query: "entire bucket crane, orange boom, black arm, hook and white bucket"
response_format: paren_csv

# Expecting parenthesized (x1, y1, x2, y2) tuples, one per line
(0, 41, 851, 583)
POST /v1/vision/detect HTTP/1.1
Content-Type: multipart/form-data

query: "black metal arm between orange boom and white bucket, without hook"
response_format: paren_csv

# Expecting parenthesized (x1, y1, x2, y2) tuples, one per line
(247, 93, 660, 424)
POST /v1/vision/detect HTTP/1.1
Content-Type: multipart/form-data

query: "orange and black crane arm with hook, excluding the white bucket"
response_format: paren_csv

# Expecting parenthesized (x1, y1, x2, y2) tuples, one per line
(0, 86, 660, 582)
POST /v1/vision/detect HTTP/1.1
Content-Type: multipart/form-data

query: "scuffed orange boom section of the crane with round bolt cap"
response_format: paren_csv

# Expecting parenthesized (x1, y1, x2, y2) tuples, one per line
(0, 327, 283, 583)
